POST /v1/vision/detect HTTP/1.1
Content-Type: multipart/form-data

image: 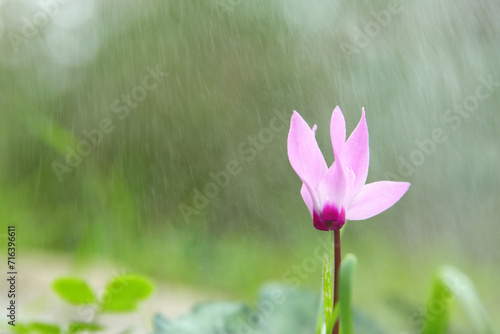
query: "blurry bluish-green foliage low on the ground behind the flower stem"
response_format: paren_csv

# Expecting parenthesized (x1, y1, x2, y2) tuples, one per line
(153, 284, 382, 334)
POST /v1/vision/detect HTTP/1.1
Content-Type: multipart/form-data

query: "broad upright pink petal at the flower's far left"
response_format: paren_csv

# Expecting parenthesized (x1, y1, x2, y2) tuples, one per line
(287, 110, 328, 192)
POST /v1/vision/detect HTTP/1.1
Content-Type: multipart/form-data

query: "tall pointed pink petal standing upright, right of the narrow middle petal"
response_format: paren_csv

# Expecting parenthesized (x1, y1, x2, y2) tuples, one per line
(341, 108, 370, 205)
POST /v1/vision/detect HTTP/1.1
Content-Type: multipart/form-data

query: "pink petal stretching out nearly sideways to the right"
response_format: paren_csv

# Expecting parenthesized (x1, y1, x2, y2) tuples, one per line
(346, 181, 410, 220)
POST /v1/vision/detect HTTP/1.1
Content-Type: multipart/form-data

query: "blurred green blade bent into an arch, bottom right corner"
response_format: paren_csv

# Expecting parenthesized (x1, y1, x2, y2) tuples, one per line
(422, 266, 493, 334)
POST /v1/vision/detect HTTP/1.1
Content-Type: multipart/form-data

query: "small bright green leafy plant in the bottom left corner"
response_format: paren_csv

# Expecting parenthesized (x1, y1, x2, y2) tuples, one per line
(14, 275, 153, 334)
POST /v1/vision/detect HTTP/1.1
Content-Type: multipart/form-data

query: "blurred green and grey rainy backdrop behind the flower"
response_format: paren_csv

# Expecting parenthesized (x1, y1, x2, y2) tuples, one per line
(0, 0, 500, 333)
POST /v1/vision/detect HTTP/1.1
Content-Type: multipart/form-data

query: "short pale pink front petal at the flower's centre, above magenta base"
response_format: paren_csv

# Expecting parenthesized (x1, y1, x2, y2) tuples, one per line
(317, 160, 347, 211)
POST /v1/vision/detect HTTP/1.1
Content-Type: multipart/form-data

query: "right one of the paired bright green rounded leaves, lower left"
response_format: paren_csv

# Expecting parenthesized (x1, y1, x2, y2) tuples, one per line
(101, 275, 153, 312)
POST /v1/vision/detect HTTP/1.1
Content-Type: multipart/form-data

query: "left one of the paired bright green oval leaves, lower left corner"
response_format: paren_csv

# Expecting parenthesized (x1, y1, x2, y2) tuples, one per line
(52, 277, 96, 305)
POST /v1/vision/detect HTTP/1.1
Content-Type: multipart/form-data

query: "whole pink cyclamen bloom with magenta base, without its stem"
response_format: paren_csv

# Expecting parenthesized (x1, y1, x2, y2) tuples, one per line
(288, 106, 410, 231)
